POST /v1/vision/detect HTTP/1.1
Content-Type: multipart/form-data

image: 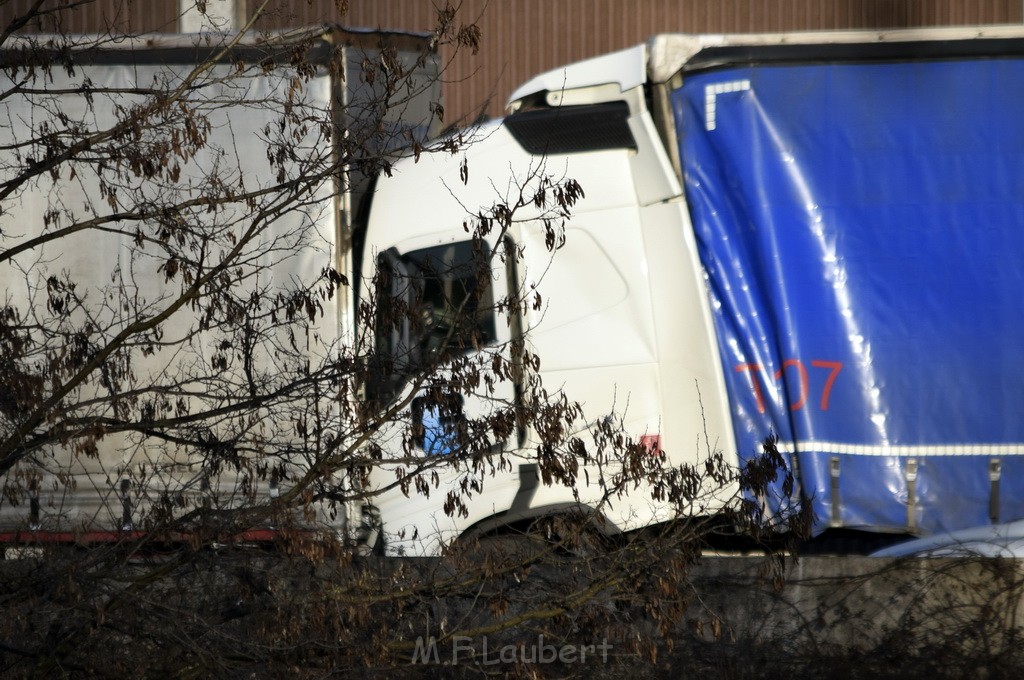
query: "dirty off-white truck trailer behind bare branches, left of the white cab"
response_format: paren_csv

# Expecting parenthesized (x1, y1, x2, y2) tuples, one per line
(0, 26, 440, 544)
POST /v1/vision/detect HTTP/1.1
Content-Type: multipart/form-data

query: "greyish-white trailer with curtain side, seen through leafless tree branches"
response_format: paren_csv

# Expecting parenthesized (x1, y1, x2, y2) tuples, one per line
(0, 27, 440, 542)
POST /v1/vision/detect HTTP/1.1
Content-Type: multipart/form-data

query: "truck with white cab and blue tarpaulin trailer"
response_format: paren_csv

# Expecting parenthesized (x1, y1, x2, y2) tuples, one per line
(360, 27, 1024, 555)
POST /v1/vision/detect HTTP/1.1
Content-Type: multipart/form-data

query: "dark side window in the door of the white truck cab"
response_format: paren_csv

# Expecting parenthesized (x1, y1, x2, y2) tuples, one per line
(375, 241, 496, 396)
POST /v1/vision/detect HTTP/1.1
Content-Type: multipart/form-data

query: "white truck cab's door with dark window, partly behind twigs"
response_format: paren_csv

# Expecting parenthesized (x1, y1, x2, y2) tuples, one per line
(360, 233, 525, 554)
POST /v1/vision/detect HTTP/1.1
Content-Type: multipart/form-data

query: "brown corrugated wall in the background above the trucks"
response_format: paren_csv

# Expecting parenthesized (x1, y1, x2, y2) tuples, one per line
(0, 0, 1024, 121)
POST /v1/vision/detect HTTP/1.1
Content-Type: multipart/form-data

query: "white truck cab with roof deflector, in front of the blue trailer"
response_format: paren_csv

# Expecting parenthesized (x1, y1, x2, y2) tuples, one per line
(362, 47, 734, 555)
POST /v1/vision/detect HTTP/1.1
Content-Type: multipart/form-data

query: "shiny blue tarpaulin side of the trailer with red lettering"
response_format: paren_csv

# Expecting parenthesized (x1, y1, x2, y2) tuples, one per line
(672, 56, 1024, 534)
